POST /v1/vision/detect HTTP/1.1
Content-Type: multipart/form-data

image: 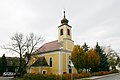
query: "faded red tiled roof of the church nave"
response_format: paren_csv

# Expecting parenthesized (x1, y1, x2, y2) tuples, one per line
(34, 40, 60, 54)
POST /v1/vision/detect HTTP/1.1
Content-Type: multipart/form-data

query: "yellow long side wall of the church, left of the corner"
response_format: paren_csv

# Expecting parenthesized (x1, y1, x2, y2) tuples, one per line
(30, 52, 59, 74)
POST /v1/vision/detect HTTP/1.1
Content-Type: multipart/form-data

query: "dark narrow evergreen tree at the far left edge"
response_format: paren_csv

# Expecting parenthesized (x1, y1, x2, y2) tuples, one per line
(0, 54, 7, 74)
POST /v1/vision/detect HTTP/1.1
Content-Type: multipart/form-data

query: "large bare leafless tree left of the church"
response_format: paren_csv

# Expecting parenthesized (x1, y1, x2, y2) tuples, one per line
(4, 33, 43, 74)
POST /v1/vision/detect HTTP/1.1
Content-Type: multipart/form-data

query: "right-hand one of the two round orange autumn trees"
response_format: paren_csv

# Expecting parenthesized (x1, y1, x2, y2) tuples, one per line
(86, 49, 100, 72)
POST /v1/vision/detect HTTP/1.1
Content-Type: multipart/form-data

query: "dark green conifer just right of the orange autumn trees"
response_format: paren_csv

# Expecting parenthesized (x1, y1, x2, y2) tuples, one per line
(94, 42, 109, 72)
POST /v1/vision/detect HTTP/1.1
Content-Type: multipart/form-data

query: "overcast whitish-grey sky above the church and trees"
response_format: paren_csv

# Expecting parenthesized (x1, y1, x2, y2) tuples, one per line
(0, 0, 120, 56)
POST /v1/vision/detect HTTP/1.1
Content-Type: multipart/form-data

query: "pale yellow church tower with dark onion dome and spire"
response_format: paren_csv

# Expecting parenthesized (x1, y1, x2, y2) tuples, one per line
(58, 11, 74, 51)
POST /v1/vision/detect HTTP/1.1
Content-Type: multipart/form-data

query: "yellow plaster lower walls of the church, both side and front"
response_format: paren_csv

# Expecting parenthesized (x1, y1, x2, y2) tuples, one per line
(30, 51, 77, 74)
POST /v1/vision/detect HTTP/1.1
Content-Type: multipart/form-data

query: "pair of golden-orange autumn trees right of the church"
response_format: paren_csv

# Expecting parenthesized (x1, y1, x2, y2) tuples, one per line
(71, 45, 100, 73)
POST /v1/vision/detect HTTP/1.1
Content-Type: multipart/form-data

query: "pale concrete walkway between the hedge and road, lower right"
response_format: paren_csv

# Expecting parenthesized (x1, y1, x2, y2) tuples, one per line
(77, 73, 120, 80)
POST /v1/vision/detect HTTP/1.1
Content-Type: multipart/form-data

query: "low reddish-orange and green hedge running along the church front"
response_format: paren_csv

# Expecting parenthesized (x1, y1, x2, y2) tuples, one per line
(17, 71, 115, 80)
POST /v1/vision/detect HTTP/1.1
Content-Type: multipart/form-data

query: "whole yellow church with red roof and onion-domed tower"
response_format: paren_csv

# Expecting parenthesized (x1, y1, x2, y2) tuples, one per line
(27, 11, 76, 74)
